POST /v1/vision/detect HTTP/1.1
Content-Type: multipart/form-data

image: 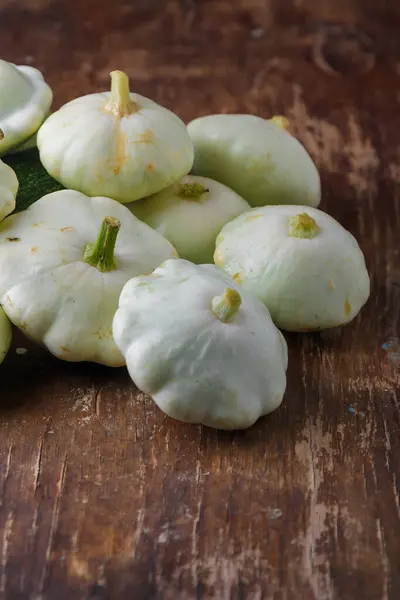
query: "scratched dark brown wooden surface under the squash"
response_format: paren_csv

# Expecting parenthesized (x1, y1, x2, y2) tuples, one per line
(0, 0, 400, 600)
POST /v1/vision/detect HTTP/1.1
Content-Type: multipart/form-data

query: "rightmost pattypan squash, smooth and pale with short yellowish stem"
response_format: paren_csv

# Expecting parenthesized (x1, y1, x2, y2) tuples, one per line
(214, 206, 370, 331)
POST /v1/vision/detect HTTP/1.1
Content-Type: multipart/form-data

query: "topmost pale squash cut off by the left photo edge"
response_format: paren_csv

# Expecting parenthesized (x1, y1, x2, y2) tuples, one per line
(0, 60, 53, 156)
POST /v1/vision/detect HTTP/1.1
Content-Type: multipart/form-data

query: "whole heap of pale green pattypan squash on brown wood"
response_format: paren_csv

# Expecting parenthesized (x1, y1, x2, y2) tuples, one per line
(0, 61, 370, 429)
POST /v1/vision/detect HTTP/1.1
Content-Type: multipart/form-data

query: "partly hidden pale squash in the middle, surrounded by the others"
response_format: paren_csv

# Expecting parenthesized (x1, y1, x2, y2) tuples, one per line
(128, 175, 250, 263)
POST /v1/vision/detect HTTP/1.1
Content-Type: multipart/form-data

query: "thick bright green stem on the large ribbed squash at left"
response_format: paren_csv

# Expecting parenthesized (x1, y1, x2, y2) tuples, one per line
(84, 217, 121, 273)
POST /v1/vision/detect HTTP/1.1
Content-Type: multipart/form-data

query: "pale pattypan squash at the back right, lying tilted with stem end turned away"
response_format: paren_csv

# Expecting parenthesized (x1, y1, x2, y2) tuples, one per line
(188, 115, 321, 206)
